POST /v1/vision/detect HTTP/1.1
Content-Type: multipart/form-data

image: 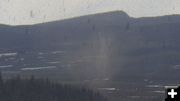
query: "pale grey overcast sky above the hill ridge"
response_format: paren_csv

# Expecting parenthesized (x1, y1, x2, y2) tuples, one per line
(0, 0, 180, 25)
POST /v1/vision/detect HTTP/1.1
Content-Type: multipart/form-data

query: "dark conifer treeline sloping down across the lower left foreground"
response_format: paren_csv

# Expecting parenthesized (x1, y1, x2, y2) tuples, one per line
(0, 73, 106, 101)
